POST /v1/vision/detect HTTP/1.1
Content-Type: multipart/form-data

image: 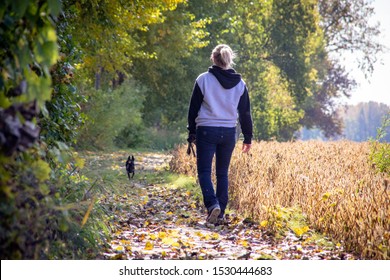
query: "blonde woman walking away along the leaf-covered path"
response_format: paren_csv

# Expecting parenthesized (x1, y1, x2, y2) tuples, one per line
(187, 44, 253, 224)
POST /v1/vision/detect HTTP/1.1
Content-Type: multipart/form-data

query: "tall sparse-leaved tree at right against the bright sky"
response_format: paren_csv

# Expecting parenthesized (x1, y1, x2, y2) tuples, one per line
(301, 0, 384, 137)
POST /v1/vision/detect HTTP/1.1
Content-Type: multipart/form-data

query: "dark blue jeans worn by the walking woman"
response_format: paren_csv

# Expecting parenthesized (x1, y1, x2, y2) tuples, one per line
(196, 126, 236, 218)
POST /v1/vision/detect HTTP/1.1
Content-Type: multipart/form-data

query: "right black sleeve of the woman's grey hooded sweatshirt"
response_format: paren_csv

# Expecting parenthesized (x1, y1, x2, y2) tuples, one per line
(238, 87, 253, 144)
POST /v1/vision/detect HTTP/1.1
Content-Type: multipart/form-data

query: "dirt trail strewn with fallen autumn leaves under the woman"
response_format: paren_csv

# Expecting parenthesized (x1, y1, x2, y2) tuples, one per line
(84, 151, 355, 260)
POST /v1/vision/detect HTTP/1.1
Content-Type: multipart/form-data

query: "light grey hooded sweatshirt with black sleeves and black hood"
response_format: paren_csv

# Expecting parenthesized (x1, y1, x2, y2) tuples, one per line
(188, 65, 253, 144)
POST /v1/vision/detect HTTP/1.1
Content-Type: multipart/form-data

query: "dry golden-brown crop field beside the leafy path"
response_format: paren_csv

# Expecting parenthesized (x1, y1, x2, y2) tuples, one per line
(171, 141, 390, 259)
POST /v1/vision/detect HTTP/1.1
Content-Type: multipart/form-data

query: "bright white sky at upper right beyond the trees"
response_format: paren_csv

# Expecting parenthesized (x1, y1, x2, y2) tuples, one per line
(345, 0, 390, 106)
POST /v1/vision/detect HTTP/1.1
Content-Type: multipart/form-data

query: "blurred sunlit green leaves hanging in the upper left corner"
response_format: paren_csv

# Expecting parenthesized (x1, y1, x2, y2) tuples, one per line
(0, 0, 60, 108)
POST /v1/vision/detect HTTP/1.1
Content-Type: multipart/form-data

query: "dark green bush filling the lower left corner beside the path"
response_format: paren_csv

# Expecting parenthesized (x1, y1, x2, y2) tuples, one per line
(0, 146, 108, 259)
